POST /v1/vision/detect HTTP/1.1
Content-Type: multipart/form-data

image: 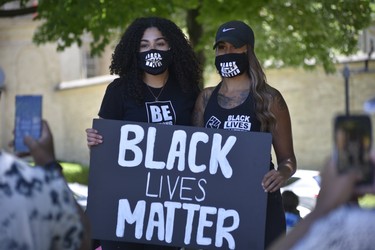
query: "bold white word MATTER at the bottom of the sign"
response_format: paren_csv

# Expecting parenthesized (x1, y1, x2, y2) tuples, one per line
(116, 199, 240, 249)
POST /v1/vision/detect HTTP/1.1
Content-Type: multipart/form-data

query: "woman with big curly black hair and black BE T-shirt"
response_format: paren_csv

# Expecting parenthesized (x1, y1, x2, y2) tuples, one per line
(86, 17, 202, 250)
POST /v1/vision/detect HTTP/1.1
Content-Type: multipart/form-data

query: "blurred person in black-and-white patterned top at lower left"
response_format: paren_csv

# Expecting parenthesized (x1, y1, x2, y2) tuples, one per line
(0, 121, 90, 250)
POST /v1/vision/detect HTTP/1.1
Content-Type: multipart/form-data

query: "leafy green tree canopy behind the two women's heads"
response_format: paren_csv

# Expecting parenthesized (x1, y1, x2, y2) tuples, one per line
(0, 0, 375, 72)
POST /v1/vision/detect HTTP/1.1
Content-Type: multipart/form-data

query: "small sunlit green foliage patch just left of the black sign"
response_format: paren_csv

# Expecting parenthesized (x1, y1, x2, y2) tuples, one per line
(60, 162, 89, 185)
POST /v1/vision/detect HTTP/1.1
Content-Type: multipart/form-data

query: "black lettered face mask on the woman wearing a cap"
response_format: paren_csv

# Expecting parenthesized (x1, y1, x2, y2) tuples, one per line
(215, 53, 249, 78)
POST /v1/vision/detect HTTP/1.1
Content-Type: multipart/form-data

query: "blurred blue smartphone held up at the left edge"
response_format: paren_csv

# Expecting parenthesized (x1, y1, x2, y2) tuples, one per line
(14, 95, 42, 153)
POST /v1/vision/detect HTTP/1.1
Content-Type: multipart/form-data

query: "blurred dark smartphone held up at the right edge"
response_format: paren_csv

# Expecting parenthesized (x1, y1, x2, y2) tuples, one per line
(334, 115, 374, 185)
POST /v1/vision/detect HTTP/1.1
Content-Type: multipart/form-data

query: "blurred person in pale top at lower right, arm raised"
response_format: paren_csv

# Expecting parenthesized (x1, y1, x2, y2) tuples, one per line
(269, 152, 375, 250)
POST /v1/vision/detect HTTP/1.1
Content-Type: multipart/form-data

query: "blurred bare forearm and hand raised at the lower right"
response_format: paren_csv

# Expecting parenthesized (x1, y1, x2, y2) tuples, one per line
(270, 158, 366, 250)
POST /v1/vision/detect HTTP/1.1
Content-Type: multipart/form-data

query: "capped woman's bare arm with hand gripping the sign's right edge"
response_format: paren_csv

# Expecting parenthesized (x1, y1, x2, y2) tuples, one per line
(262, 90, 297, 192)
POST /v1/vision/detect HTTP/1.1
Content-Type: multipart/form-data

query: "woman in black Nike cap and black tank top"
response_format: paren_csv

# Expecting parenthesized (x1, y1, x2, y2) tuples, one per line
(193, 21, 297, 247)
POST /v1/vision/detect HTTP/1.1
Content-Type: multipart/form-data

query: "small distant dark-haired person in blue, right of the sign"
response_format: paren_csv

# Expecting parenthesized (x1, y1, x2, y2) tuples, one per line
(281, 190, 301, 232)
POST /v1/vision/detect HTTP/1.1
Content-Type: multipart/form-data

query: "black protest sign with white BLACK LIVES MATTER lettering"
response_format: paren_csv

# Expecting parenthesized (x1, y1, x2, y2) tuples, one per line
(87, 119, 271, 249)
